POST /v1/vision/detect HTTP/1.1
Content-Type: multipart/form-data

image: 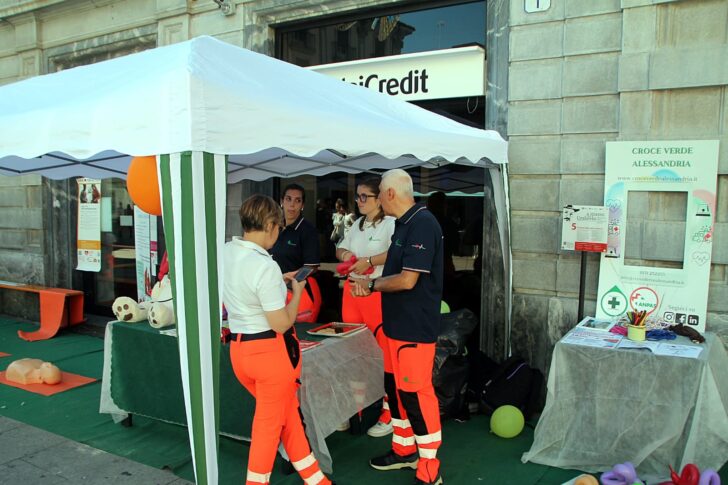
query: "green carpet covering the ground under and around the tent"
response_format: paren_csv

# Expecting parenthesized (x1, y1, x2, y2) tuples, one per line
(0, 318, 728, 485)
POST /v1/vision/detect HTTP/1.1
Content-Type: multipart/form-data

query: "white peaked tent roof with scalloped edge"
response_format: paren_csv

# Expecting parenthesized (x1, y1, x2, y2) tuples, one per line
(0, 37, 507, 182)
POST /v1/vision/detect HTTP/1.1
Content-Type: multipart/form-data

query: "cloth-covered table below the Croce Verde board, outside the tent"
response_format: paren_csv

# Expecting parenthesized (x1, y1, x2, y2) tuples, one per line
(521, 333, 728, 479)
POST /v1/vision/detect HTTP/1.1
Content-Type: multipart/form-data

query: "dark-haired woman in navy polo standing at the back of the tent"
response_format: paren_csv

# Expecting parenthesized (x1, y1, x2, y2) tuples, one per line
(270, 184, 321, 322)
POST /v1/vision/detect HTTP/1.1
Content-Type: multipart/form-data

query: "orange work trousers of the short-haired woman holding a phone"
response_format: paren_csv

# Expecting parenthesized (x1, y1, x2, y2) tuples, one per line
(230, 329, 331, 485)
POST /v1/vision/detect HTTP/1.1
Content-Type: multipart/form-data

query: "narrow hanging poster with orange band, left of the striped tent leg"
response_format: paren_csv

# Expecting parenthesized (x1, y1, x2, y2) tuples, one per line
(76, 178, 101, 272)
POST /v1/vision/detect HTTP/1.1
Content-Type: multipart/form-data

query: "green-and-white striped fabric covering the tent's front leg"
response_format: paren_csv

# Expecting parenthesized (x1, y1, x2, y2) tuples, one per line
(157, 152, 227, 485)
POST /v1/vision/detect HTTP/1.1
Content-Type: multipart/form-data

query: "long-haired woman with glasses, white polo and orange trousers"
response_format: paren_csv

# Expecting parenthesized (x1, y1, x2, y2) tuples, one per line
(336, 177, 397, 437)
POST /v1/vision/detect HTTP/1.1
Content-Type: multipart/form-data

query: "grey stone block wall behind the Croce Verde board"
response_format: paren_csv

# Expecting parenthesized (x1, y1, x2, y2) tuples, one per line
(508, 0, 728, 370)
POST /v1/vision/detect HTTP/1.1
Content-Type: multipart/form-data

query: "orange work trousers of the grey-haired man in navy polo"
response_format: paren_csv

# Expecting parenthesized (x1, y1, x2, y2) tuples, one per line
(387, 338, 442, 483)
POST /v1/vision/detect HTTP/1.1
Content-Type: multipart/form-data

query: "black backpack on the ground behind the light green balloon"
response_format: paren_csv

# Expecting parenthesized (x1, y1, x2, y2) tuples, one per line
(480, 355, 543, 419)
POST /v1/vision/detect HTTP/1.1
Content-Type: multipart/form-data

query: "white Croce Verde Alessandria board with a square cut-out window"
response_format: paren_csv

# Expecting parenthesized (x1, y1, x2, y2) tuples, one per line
(597, 140, 718, 332)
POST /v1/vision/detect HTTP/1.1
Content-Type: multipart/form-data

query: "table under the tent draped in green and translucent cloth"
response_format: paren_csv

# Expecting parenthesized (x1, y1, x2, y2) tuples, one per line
(99, 321, 384, 472)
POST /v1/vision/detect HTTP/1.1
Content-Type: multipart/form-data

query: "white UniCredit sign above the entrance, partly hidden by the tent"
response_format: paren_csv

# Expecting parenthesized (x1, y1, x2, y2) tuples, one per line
(309, 46, 485, 101)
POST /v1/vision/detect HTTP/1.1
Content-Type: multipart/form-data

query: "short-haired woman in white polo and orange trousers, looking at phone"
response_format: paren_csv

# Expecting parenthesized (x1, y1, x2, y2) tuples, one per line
(223, 195, 331, 485)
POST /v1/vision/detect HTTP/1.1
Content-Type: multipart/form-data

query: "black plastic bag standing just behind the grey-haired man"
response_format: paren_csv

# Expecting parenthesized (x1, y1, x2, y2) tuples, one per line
(432, 308, 478, 418)
